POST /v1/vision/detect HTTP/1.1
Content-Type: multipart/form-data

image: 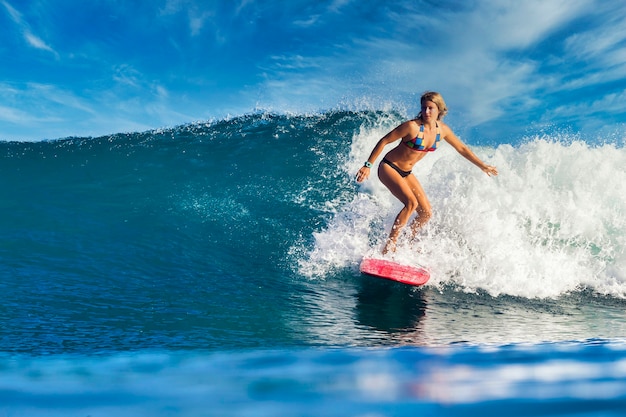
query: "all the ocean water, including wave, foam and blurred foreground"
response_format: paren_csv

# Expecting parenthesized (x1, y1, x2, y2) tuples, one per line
(0, 111, 626, 416)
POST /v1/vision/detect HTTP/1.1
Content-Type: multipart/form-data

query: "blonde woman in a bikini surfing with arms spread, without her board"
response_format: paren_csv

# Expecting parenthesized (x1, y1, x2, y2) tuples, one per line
(356, 91, 498, 254)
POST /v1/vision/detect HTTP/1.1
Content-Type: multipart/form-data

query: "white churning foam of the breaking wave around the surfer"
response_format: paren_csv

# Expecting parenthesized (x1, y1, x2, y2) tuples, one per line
(300, 126, 626, 298)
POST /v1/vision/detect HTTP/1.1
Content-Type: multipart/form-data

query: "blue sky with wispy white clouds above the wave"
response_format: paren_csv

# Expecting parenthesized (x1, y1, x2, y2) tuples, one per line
(0, 0, 626, 142)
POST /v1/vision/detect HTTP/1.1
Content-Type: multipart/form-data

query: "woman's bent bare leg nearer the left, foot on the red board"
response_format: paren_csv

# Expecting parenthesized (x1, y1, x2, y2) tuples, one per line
(378, 164, 416, 254)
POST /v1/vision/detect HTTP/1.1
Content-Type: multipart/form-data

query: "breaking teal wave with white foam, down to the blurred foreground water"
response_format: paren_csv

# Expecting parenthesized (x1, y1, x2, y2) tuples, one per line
(0, 112, 626, 354)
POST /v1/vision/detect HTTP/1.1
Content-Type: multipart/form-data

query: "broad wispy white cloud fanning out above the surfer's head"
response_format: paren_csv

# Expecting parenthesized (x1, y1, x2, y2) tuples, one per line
(252, 0, 593, 127)
